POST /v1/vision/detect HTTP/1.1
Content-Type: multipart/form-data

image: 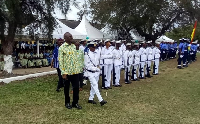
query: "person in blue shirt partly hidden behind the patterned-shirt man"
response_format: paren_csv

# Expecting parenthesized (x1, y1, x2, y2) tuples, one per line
(51, 40, 64, 92)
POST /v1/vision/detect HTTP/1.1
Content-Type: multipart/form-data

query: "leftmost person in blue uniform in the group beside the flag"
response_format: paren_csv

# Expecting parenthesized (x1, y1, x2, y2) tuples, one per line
(177, 39, 184, 69)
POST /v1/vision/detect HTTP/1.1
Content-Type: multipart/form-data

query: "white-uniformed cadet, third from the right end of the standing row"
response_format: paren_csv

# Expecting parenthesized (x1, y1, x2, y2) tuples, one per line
(138, 42, 147, 79)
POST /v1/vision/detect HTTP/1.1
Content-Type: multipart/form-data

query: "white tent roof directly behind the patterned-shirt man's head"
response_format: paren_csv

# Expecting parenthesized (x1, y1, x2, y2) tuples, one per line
(52, 19, 86, 39)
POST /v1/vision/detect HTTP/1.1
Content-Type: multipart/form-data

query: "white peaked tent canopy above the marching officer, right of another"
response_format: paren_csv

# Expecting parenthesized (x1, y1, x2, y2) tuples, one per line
(75, 16, 110, 40)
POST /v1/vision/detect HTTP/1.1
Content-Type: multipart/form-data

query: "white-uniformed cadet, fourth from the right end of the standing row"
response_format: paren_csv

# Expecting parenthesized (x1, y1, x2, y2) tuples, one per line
(131, 43, 140, 81)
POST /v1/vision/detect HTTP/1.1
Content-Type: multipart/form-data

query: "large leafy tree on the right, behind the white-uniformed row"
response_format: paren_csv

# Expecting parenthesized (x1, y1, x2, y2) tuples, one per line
(89, 0, 200, 42)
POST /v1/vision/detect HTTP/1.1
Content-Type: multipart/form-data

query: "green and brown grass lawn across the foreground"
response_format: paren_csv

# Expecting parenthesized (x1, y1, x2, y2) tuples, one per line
(0, 56, 200, 124)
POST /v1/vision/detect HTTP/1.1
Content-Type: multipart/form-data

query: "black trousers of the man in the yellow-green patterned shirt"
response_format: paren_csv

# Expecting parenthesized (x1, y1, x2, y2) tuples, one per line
(64, 74, 79, 105)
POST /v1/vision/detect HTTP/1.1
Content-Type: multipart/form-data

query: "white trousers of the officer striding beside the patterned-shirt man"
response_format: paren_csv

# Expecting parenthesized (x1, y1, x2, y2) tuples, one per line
(88, 76, 103, 102)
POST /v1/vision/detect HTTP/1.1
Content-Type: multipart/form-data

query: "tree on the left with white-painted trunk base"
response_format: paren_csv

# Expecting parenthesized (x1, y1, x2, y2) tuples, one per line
(0, 0, 70, 73)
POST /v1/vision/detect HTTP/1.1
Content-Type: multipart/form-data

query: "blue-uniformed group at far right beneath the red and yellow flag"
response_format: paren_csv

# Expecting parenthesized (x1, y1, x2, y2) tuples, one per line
(177, 38, 199, 69)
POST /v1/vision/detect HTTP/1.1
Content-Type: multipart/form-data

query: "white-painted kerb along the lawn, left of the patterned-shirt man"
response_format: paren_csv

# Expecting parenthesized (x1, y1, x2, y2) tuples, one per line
(0, 70, 57, 84)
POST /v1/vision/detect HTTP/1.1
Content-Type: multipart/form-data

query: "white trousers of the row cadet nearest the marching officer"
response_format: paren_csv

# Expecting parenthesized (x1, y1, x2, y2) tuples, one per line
(104, 64, 113, 87)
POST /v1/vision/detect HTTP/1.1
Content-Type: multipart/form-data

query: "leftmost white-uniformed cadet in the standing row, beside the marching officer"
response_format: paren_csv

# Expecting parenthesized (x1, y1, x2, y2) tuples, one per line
(100, 39, 113, 89)
